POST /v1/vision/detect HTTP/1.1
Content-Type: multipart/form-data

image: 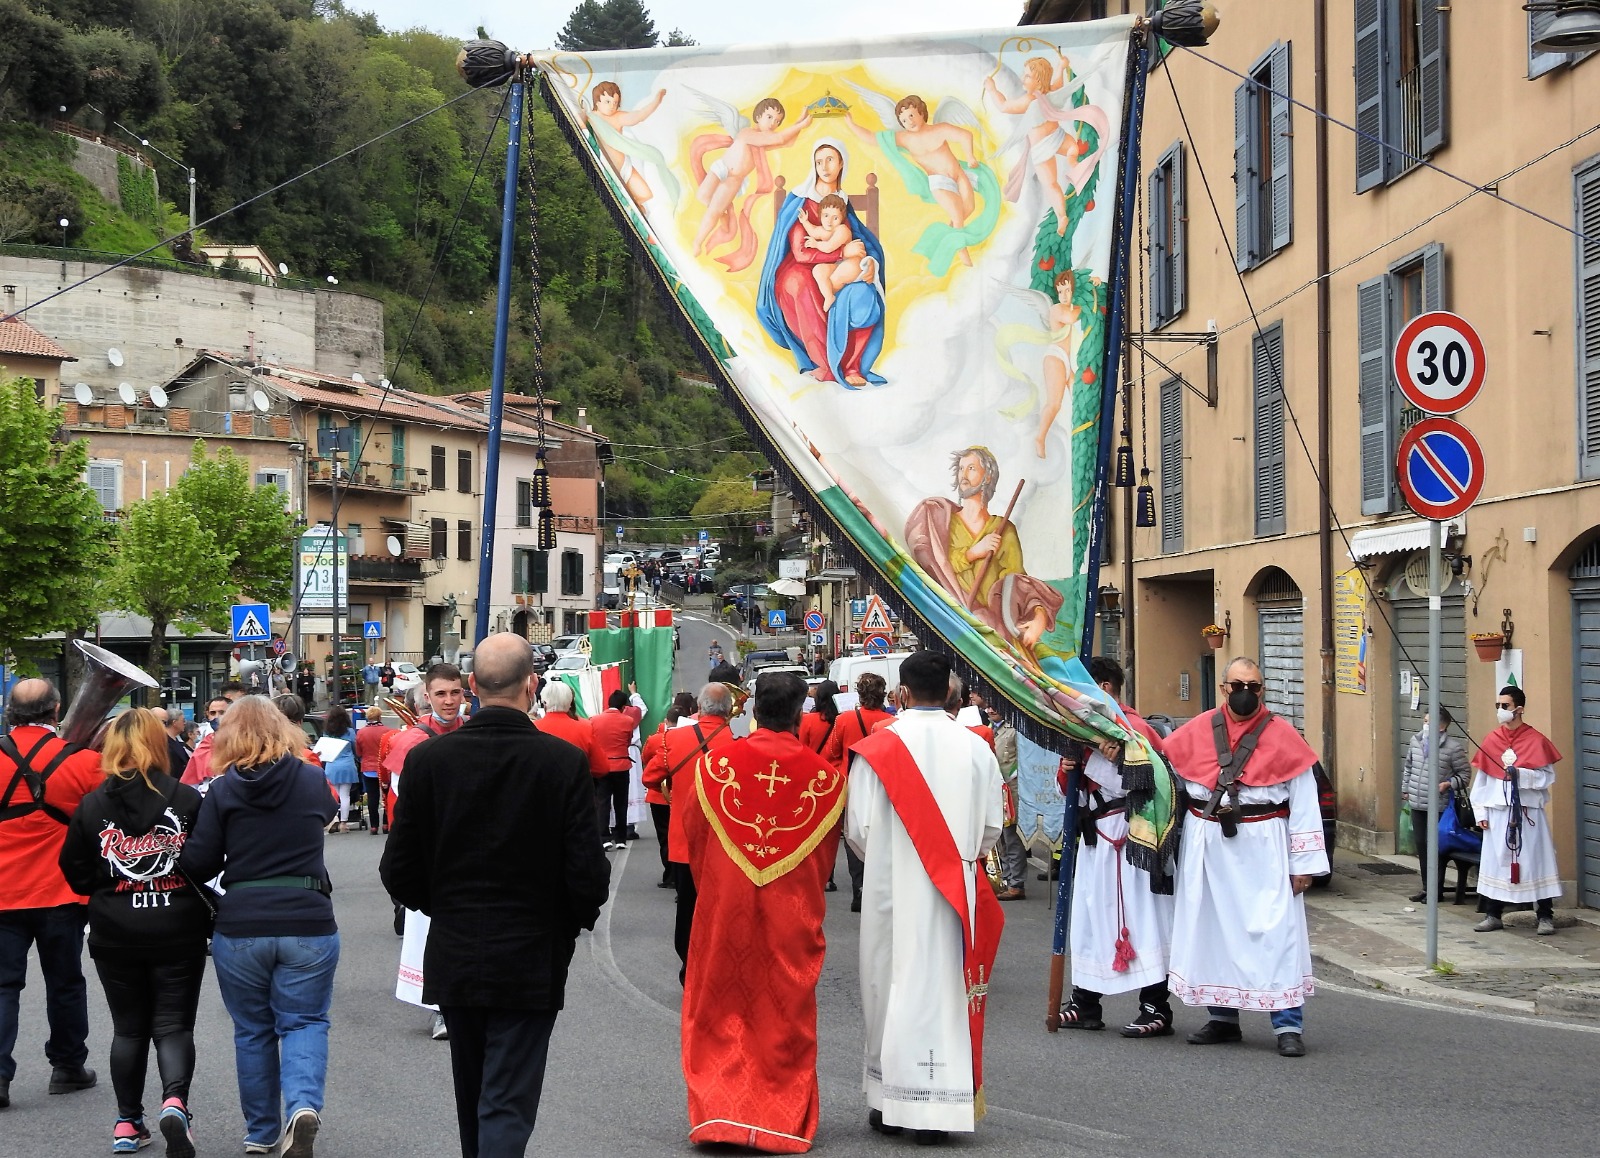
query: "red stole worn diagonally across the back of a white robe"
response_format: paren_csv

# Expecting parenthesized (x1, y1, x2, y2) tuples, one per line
(850, 729, 1005, 1118)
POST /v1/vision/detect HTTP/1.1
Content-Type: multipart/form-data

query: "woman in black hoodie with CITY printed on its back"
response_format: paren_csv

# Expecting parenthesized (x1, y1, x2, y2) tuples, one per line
(61, 709, 211, 1158)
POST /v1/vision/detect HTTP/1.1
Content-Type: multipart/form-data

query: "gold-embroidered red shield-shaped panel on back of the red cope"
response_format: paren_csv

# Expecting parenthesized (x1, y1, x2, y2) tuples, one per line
(694, 729, 845, 886)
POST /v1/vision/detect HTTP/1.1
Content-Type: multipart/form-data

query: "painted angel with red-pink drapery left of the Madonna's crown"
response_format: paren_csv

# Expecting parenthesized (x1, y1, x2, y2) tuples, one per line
(685, 86, 811, 274)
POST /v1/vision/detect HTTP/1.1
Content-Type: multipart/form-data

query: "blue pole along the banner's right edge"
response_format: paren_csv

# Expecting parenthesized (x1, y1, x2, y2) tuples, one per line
(1051, 38, 1150, 956)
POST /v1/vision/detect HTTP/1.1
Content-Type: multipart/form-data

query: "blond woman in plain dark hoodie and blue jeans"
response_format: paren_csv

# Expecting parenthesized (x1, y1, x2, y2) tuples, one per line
(181, 696, 339, 1158)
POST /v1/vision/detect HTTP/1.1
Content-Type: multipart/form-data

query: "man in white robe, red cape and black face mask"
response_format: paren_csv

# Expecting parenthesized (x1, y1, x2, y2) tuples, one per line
(1165, 659, 1328, 1057)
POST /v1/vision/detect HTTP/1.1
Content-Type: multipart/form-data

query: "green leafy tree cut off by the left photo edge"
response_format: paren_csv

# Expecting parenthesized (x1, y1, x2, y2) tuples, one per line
(0, 377, 109, 667)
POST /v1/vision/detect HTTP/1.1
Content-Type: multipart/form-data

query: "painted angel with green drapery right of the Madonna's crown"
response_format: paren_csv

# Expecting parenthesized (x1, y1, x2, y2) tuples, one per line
(845, 82, 1000, 277)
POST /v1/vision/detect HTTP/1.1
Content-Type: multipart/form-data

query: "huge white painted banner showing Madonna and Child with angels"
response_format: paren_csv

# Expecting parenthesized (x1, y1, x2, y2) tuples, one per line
(534, 18, 1133, 736)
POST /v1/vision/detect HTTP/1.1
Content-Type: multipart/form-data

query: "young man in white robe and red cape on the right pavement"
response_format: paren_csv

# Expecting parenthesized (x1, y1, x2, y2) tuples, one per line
(1472, 685, 1562, 937)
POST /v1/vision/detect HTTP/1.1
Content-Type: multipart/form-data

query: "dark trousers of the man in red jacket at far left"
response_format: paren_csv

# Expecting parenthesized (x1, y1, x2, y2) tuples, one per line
(0, 904, 90, 1081)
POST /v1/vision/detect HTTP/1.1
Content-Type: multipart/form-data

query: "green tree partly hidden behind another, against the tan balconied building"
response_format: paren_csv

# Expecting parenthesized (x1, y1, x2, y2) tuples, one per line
(173, 440, 294, 608)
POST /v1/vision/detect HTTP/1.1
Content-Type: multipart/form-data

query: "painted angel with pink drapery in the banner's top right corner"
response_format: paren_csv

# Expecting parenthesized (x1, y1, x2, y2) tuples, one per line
(984, 51, 1110, 237)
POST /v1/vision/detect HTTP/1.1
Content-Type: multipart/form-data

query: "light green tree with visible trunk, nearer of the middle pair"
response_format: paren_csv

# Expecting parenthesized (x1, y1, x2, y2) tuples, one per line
(106, 488, 237, 680)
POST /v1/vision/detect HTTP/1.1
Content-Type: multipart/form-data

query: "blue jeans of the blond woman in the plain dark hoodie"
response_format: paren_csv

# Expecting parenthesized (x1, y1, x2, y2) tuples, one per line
(211, 932, 339, 1145)
